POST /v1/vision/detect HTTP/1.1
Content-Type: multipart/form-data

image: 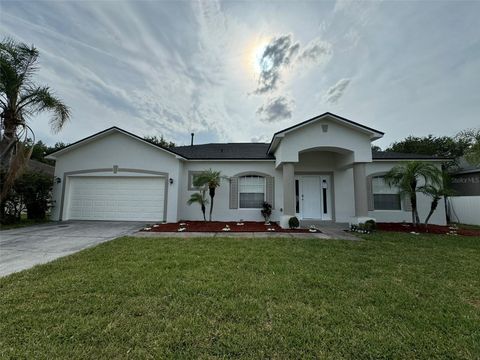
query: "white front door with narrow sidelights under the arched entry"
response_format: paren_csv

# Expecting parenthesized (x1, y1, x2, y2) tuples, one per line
(295, 175, 332, 220)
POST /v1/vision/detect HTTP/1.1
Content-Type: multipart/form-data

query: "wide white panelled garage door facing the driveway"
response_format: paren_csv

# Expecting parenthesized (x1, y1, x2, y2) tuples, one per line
(67, 176, 165, 221)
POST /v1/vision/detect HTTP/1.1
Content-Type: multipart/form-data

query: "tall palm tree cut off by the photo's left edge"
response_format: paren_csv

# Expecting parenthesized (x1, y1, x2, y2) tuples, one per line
(0, 39, 70, 200)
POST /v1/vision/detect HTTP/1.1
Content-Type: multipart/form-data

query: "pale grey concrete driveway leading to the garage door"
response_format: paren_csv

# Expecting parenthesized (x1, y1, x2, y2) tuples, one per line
(0, 221, 145, 276)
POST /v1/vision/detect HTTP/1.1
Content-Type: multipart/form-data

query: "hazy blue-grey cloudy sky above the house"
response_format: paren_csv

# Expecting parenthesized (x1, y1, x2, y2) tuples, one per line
(0, 0, 480, 148)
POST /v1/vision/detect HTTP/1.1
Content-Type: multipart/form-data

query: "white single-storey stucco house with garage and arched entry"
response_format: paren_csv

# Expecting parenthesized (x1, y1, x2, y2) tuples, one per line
(48, 113, 445, 225)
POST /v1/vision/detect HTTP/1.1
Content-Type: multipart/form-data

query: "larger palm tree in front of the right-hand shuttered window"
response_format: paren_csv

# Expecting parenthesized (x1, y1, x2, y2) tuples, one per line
(385, 161, 441, 226)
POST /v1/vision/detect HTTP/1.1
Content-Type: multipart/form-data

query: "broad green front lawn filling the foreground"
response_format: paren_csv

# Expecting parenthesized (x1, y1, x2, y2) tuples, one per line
(0, 233, 480, 359)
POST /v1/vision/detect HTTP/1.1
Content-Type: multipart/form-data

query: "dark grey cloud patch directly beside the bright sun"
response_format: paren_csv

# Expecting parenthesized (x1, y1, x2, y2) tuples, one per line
(255, 34, 300, 94)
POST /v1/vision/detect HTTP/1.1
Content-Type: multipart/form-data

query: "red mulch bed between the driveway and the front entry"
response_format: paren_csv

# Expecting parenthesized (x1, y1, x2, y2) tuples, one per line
(141, 221, 314, 233)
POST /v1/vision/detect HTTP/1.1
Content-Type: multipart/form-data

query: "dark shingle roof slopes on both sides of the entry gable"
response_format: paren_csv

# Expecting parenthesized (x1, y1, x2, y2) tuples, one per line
(172, 143, 446, 160)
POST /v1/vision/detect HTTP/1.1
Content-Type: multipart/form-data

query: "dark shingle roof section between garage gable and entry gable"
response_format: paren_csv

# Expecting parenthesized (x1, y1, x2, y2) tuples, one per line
(173, 143, 275, 160)
